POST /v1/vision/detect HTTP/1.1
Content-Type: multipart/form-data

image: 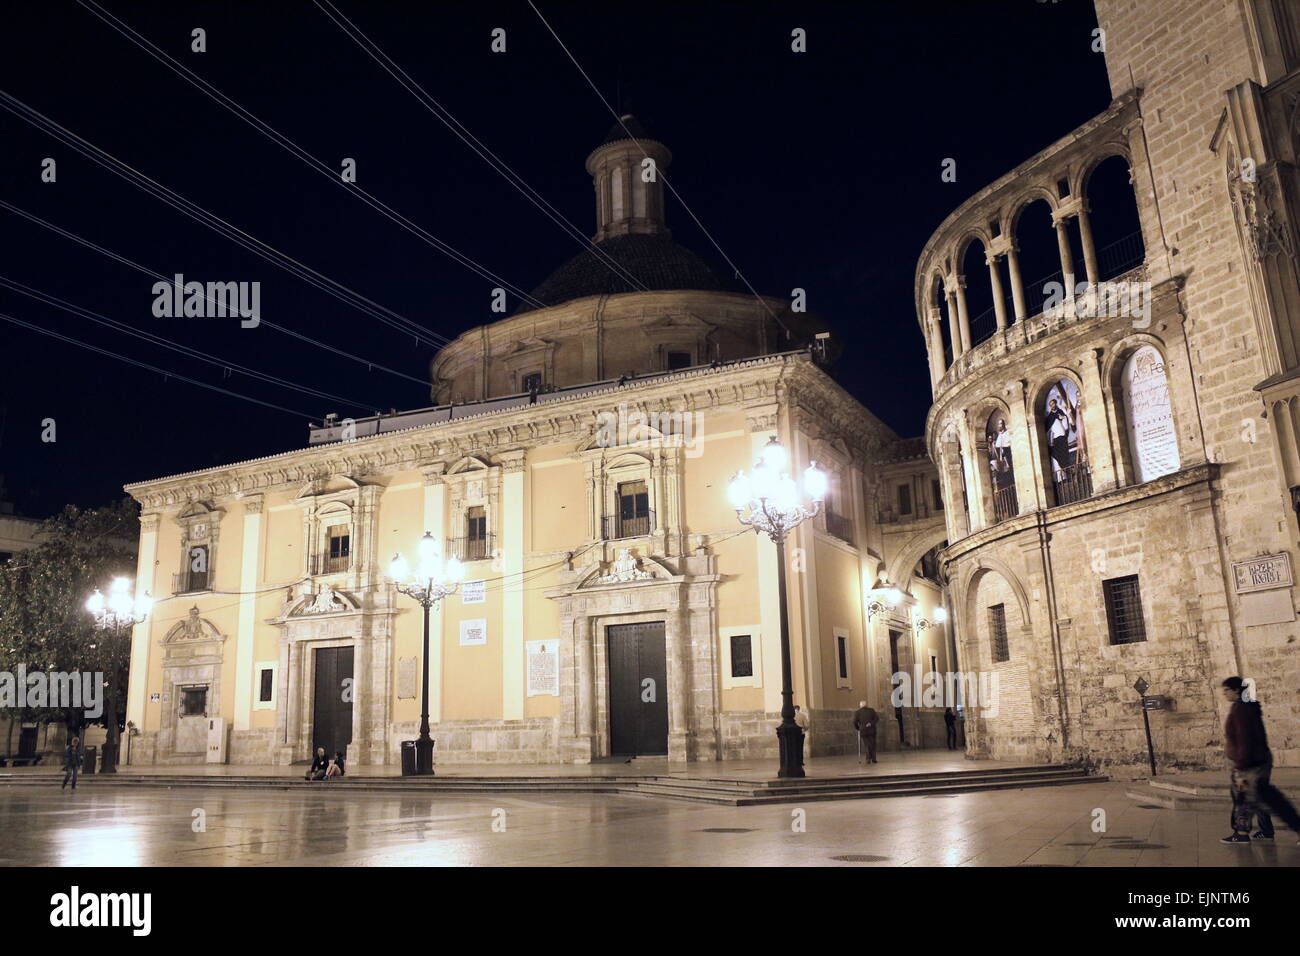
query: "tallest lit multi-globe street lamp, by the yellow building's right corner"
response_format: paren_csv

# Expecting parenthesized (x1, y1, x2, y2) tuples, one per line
(727, 436, 826, 777)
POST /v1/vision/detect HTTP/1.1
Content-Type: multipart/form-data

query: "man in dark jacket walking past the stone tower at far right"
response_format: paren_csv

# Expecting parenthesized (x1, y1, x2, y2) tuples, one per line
(1221, 678, 1300, 845)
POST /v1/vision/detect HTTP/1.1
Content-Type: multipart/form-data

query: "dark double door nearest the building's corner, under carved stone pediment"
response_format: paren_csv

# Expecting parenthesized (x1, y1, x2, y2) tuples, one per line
(606, 620, 668, 756)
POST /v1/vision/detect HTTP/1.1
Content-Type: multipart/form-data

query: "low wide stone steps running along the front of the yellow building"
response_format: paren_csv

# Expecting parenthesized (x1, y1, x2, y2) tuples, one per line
(0, 765, 1109, 806)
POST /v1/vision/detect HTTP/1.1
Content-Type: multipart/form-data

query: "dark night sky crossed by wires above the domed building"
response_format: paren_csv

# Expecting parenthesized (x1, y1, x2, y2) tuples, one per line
(0, 0, 1110, 516)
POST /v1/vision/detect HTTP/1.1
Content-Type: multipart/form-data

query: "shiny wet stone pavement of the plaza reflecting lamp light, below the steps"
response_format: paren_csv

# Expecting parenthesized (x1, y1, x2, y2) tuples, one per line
(0, 783, 1300, 866)
